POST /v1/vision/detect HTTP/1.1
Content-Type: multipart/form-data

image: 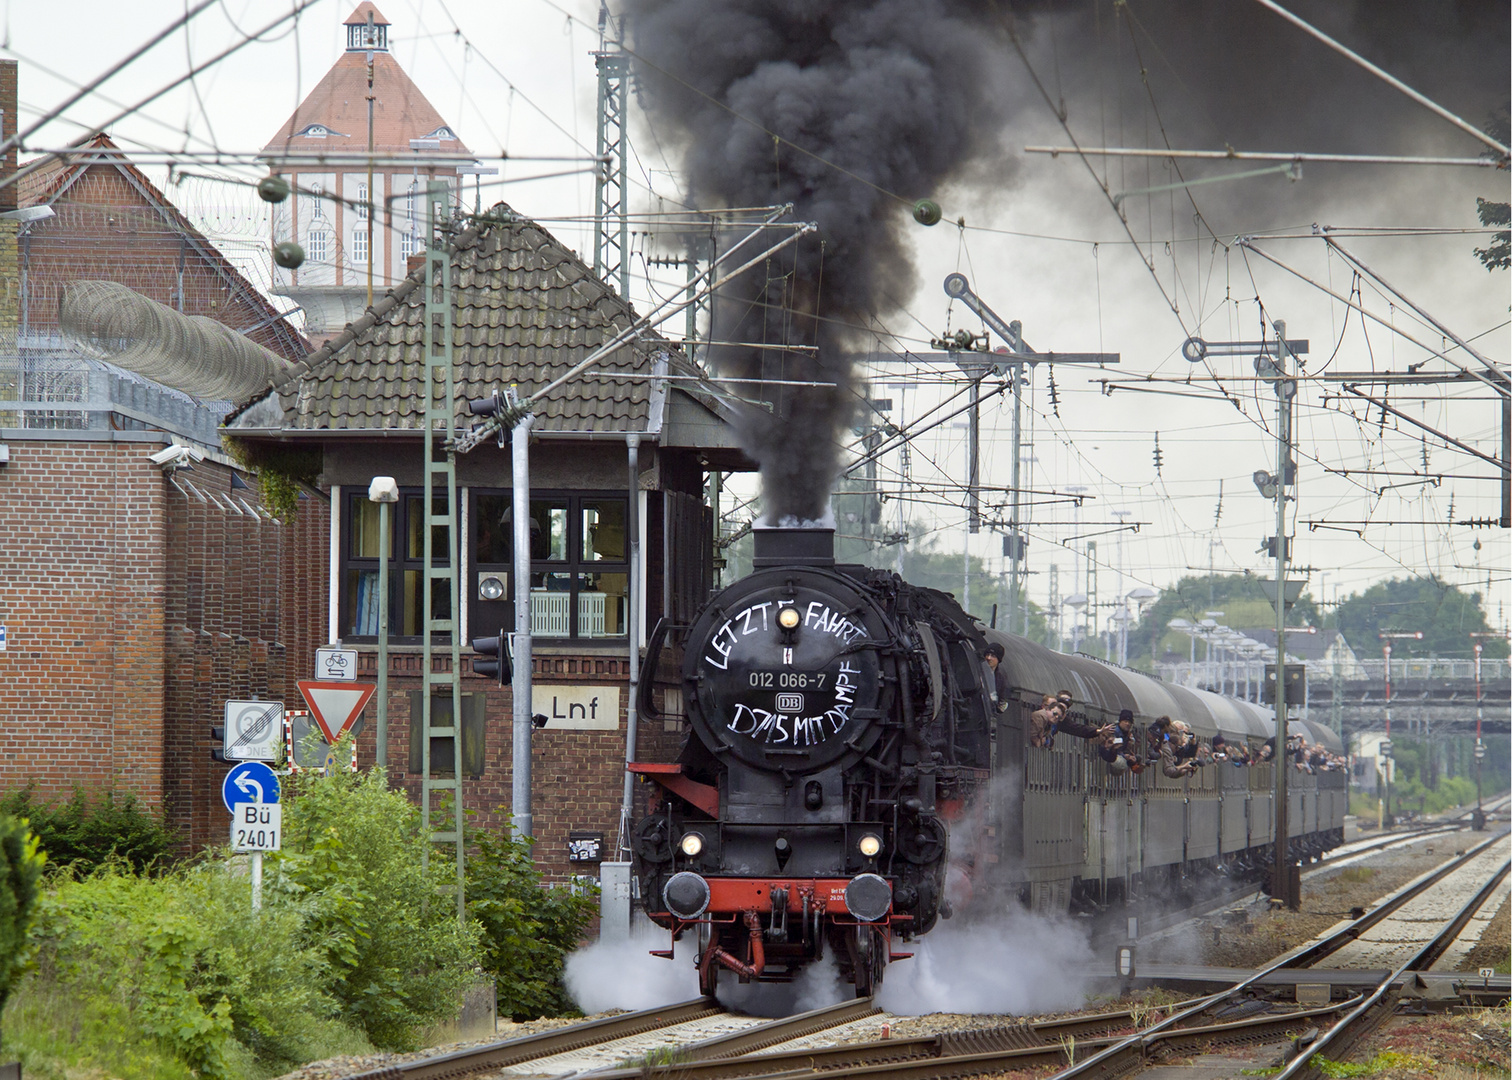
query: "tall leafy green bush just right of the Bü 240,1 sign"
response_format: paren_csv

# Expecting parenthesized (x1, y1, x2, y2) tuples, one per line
(268, 747, 481, 1050)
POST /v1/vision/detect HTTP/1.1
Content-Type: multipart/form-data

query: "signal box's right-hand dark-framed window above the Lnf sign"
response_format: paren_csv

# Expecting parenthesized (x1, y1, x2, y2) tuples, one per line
(470, 492, 631, 640)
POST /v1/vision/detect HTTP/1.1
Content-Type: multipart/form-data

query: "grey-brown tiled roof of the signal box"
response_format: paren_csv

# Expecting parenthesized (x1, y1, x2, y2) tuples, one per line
(227, 203, 702, 433)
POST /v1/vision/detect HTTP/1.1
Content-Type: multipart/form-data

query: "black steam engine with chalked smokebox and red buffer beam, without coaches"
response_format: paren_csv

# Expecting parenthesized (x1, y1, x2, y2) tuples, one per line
(619, 528, 995, 995)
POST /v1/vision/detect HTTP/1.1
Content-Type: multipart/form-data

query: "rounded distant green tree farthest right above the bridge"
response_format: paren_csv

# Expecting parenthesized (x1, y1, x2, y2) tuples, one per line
(1338, 578, 1507, 659)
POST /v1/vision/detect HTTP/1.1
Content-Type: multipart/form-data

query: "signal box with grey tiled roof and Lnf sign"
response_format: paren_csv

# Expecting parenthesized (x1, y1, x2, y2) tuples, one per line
(227, 204, 751, 877)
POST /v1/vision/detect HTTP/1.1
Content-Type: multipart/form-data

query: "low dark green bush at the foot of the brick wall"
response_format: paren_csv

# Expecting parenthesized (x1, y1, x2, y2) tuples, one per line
(0, 787, 178, 874)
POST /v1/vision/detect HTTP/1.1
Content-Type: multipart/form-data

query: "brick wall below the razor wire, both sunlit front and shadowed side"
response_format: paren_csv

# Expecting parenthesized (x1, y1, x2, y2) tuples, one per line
(0, 440, 330, 846)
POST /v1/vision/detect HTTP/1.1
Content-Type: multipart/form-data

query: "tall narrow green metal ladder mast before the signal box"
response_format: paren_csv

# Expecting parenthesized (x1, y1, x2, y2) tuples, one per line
(411, 180, 467, 921)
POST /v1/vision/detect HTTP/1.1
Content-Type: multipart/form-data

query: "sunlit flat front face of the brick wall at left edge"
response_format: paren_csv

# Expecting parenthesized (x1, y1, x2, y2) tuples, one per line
(0, 442, 166, 806)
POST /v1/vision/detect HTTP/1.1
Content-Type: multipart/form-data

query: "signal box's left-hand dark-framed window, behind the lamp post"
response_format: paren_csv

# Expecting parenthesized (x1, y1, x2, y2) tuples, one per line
(340, 489, 451, 641)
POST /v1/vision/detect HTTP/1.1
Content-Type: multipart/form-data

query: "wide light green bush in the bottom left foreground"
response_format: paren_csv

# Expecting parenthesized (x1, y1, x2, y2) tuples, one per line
(17, 859, 364, 1080)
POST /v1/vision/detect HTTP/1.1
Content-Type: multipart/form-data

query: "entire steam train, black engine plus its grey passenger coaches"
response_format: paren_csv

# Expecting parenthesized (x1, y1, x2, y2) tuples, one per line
(631, 528, 1347, 995)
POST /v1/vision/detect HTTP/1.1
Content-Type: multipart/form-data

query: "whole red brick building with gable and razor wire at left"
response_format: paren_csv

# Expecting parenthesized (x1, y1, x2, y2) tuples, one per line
(0, 62, 328, 839)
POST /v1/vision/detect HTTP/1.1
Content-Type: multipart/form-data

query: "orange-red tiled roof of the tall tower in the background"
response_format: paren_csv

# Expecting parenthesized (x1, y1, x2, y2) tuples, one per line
(263, 53, 472, 157)
